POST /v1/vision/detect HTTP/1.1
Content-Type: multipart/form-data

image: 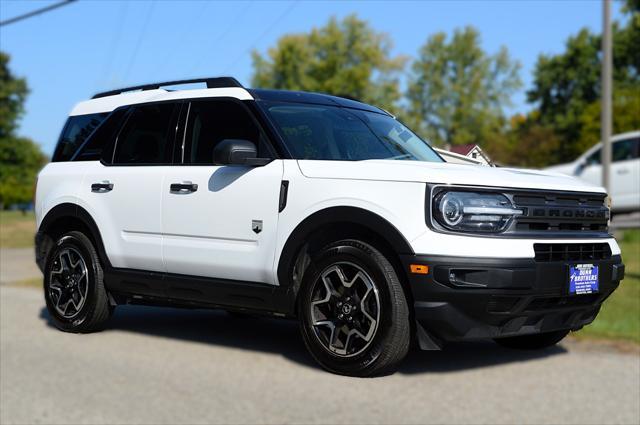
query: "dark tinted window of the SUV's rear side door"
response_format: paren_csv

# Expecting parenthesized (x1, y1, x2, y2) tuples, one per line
(113, 103, 175, 164)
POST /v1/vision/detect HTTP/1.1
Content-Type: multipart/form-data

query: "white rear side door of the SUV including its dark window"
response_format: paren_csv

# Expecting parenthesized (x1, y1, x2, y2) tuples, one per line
(82, 102, 181, 272)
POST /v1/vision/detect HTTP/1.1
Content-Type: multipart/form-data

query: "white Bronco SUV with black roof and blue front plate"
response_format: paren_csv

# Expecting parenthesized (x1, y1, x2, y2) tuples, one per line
(36, 77, 624, 376)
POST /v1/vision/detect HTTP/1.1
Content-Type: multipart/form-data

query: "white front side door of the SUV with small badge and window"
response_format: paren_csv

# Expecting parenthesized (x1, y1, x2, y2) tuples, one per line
(162, 98, 283, 283)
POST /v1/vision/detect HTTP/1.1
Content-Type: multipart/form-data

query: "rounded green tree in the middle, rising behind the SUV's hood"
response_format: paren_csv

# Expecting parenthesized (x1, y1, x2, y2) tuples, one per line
(403, 27, 522, 147)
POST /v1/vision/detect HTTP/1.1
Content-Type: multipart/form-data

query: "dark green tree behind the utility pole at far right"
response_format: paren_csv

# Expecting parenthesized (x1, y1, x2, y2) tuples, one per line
(527, 0, 640, 162)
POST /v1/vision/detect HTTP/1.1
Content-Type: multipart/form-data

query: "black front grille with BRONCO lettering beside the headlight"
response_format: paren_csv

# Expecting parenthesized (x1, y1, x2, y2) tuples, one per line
(511, 192, 609, 234)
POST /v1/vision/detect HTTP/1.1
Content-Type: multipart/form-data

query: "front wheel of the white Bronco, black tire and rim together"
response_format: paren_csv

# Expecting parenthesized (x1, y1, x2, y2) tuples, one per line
(298, 239, 411, 377)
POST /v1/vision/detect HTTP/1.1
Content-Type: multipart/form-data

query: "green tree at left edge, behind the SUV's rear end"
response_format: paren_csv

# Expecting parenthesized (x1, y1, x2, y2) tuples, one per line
(0, 52, 47, 209)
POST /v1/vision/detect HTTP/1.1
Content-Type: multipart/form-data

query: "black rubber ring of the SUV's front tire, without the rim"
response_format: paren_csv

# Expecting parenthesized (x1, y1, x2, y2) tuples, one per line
(298, 244, 404, 375)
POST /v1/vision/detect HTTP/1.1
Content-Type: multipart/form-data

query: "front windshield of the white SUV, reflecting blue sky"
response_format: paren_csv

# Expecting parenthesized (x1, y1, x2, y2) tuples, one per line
(263, 102, 442, 162)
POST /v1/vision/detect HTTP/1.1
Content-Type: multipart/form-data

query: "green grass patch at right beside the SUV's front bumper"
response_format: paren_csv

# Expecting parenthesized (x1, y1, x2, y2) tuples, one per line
(574, 229, 640, 344)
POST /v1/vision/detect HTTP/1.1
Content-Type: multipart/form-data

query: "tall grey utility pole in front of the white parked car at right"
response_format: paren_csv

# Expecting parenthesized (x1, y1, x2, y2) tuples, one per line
(600, 0, 612, 193)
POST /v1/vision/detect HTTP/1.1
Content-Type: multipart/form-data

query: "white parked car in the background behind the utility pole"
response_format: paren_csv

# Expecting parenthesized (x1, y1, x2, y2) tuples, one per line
(547, 131, 640, 213)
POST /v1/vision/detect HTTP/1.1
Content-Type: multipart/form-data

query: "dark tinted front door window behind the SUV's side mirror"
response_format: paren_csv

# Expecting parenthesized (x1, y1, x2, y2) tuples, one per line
(184, 100, 270, 164)
